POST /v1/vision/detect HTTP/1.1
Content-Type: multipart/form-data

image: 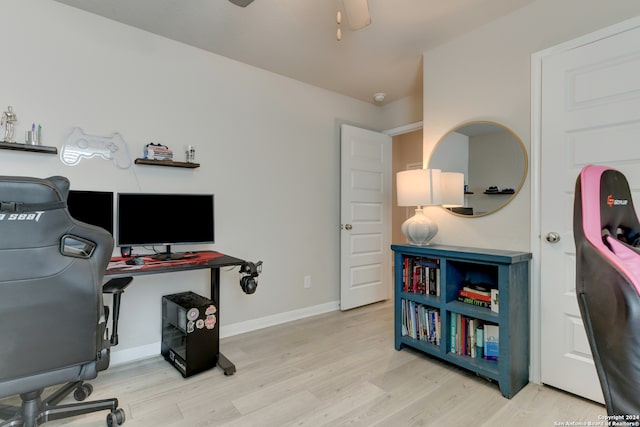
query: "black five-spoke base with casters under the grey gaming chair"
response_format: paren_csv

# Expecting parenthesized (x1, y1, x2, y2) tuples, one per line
(0, 381, 125, 427)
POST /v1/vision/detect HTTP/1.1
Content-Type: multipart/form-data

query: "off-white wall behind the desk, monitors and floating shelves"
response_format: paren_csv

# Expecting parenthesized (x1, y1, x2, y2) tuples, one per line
(0, 0, 412, 362)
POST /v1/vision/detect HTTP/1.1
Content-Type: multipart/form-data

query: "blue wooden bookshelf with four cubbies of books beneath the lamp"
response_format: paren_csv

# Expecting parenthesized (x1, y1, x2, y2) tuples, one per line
(391, 245, 531, 399)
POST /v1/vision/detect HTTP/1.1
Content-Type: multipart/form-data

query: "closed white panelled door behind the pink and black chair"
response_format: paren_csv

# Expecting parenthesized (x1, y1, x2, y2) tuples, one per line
(540, 20, 640, 402)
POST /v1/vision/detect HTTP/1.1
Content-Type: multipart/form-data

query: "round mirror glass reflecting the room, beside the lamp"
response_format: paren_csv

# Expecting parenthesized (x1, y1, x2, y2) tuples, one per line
(429, 121, 527, 216)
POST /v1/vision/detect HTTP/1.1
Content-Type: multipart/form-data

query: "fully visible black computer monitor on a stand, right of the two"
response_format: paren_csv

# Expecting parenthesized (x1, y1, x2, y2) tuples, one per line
(116, 193, 215, 259)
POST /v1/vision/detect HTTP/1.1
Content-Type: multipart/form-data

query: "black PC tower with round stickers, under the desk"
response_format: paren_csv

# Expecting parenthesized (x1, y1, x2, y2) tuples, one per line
(161, 292, 219, 378)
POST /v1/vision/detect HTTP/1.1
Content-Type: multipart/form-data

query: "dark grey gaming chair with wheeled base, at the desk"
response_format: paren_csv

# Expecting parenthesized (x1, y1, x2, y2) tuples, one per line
(0, 176, 124, 427)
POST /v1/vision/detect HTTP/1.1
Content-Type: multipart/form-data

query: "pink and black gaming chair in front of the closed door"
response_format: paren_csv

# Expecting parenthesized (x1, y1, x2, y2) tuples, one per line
(573, 165, 640, 416)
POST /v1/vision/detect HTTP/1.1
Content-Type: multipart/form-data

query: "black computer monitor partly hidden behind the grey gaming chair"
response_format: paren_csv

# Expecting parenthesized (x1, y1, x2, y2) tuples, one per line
(67, 190, 113, 235)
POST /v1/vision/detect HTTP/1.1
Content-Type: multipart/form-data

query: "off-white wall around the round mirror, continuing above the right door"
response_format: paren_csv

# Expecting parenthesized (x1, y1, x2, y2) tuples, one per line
(423, 0, 640, 251)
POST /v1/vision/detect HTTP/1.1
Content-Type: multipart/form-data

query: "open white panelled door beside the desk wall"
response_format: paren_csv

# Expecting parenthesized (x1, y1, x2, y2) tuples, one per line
(340, 125, 391, 310)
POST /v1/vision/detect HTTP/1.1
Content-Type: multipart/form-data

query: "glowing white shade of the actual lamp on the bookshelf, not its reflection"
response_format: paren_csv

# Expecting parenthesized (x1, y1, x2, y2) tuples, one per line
(396, 169, 442, 206)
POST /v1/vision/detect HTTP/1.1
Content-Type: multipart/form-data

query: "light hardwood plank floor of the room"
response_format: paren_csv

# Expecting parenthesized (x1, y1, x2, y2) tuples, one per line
(3, 301, 606, 427)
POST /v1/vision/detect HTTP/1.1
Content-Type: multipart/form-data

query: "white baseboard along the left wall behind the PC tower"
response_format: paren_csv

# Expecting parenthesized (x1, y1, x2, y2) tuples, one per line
(111, 301, 340, 366)
